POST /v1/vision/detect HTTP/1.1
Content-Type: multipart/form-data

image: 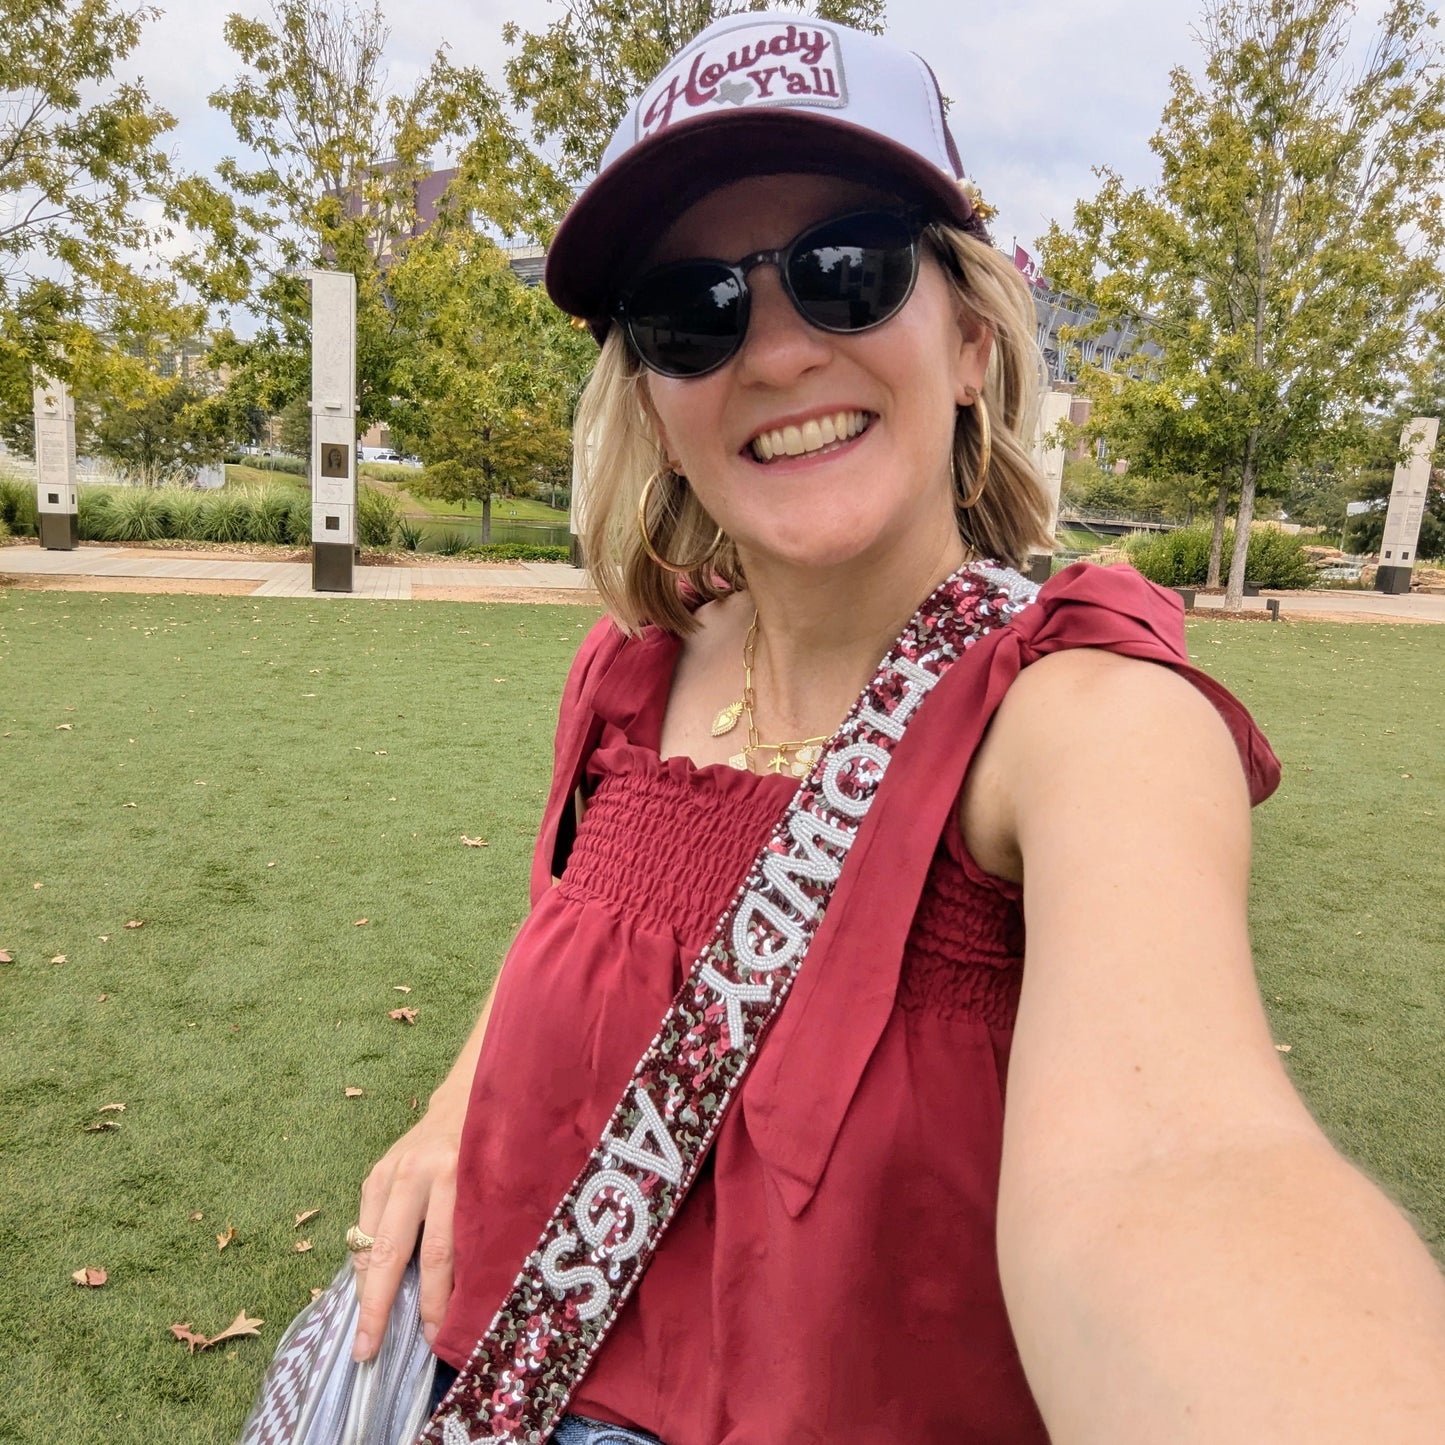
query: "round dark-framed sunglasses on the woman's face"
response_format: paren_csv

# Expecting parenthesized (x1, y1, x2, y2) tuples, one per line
(614, 211, 923, 377)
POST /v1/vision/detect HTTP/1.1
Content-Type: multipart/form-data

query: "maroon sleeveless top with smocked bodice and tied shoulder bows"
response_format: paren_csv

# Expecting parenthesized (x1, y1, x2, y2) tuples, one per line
(435, 566, 1279, 1445)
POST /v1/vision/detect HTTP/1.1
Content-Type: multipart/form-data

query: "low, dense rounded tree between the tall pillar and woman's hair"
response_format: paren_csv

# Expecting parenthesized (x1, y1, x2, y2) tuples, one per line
(392, 227, 595, 542)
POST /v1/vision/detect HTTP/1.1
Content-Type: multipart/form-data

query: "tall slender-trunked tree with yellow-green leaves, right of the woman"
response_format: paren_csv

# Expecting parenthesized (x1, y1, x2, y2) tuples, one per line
(1042, 0, 1445, 604)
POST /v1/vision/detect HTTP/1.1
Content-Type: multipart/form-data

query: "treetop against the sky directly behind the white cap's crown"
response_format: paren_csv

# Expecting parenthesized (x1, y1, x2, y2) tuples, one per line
(501, 0, 883, 206)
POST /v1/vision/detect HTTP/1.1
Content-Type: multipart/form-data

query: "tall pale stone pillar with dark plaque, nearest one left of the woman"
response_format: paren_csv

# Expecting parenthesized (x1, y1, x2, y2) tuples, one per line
(308, 270, 357, 592)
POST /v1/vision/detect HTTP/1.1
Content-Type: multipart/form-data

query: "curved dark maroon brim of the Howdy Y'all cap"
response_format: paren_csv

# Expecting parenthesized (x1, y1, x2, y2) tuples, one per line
(543, 107, 974, 341)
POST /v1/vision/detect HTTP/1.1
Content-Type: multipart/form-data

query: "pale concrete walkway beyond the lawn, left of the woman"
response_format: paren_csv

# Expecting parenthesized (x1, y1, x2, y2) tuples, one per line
(0, 543, 591, 601)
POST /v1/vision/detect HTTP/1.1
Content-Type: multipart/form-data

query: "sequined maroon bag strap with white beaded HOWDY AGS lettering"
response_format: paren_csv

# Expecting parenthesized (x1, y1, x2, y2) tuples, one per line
(420, 566, 1035, 1445)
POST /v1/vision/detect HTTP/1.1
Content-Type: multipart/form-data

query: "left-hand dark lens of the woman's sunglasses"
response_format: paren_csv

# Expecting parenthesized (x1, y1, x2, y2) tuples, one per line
(627, 262, 744, 376)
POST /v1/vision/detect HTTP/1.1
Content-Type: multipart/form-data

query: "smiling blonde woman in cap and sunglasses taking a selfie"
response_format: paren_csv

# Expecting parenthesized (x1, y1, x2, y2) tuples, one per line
(346, 14, 1445, 1445)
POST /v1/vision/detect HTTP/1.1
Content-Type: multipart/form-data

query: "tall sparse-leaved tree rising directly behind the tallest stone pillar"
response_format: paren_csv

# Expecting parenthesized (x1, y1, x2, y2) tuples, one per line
(197, 0, 546, 428)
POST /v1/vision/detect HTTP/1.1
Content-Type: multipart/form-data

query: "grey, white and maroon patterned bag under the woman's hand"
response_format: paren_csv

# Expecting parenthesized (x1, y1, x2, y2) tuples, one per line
(241, 1259, 436, 1445)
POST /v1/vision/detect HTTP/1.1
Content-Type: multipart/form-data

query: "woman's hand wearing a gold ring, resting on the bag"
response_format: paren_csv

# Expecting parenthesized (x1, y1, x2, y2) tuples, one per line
(351, 1098, 465, 1360)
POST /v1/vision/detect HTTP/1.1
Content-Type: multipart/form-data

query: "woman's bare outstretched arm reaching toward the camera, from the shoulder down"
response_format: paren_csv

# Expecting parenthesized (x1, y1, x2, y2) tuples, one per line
(982, 652, 1445, 1445)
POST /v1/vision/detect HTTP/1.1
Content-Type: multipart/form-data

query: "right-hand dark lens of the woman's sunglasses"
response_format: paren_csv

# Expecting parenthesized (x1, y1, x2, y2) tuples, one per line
(788, 214, 918, 331)
